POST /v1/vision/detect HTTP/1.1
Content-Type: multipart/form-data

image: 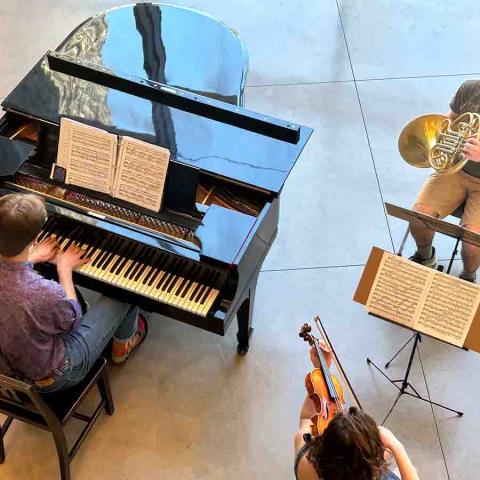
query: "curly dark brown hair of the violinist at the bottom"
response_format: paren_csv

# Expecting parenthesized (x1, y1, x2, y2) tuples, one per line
(307, 407, 387, 480)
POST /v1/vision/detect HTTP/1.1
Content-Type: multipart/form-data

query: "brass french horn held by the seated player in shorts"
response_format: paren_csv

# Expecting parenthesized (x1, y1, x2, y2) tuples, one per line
(398, 113, 480, 174)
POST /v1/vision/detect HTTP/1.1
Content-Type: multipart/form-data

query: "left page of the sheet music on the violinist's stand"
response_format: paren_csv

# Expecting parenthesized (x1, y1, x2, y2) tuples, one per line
(365, 252, 434, 327)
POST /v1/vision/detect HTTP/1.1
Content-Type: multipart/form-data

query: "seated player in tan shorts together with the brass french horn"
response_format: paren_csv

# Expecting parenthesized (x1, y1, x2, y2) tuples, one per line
(399, 80, 480, 282)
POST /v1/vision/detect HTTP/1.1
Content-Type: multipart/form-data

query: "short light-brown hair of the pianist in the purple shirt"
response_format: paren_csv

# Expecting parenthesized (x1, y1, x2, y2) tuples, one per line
(0, 193, 47, 257)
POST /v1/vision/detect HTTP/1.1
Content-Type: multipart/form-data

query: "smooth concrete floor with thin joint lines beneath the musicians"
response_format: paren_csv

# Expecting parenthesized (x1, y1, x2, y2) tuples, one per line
(0, 0, 480, 480)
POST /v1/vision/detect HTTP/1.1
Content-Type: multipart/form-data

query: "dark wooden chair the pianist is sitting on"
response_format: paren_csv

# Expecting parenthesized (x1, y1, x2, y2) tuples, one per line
(0, 358, 114, 480)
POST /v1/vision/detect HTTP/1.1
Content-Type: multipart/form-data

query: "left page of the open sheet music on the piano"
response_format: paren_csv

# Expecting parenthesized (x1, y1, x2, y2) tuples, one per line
(57, 118, 117, 193)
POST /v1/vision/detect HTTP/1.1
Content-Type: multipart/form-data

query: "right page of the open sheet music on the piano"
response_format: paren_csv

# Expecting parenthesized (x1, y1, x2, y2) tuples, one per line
(112, 137, 170, 212)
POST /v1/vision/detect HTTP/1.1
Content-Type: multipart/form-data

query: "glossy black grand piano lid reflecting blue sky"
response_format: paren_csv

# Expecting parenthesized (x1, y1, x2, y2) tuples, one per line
(2, 4, 312, 193)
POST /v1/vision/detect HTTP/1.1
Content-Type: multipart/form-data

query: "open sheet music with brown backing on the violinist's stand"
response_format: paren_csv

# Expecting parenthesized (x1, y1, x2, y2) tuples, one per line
(353, 247, 480, 352)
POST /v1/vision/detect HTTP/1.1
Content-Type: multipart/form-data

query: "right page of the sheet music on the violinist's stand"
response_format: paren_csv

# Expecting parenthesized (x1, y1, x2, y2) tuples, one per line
(413, 272, 480, 347)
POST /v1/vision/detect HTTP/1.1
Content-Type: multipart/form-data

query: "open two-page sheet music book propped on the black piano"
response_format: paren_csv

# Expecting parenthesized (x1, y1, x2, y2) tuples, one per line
(51, 117, 170, 212)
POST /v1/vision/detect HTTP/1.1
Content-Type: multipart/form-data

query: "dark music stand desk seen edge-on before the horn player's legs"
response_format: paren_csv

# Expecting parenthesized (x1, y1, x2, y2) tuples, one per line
(385, 202, 480, 247)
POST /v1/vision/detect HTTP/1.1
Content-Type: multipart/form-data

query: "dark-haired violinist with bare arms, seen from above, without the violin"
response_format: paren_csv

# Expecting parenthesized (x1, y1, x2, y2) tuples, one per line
(295, 342, 419, 480)
